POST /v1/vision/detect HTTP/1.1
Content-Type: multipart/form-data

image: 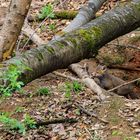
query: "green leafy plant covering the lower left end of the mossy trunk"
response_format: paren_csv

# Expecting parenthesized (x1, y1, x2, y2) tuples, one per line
(0, 61, 31, 96)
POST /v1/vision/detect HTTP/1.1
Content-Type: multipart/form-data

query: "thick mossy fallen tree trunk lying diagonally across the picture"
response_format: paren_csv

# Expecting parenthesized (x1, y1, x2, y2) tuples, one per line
(0, 0, 140, 83)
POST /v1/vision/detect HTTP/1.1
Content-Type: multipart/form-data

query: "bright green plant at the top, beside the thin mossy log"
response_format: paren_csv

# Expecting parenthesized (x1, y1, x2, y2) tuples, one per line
(38, 4, 54, 19)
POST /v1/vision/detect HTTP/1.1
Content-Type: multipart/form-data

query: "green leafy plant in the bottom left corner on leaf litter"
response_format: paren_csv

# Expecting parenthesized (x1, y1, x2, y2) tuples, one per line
(0, 115, 26, 134)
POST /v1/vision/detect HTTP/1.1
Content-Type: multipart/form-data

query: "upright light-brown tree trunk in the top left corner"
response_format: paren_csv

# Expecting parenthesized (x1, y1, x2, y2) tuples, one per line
(0, 0, 32, 60)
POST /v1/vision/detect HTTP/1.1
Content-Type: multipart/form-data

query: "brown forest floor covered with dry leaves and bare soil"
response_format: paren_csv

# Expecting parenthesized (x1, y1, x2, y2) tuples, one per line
(0, 0, 140, 140)
